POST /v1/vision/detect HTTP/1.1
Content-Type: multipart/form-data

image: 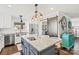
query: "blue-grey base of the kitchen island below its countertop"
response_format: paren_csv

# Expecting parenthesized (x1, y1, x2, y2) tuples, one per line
(21, 39, 56, 55)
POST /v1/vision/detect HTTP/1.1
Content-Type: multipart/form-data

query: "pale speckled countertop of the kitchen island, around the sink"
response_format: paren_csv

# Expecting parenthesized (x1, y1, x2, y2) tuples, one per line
(22, 36, 60, 52)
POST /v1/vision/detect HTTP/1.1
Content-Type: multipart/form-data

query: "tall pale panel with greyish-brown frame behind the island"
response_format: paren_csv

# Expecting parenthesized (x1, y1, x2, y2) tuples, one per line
(47, 17, 58, 35)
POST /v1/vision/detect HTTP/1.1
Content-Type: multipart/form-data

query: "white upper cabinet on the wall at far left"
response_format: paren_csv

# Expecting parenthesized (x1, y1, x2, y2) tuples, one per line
(0, 15, 12, 28)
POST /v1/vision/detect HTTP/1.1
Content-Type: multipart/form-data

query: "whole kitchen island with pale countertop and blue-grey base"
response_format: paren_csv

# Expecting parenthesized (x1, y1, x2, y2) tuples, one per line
(21, 35, 60, 55)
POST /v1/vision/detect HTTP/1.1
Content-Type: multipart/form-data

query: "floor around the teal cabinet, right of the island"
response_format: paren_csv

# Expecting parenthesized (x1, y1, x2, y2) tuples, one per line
(58, 39, 79, 55)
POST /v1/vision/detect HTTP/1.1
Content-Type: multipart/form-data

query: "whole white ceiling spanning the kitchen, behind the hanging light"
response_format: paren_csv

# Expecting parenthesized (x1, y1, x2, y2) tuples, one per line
(0, 4, 79, 18)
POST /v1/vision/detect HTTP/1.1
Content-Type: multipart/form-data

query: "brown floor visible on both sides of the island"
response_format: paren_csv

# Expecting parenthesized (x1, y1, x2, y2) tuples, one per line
(1, 39, 79, 55)
